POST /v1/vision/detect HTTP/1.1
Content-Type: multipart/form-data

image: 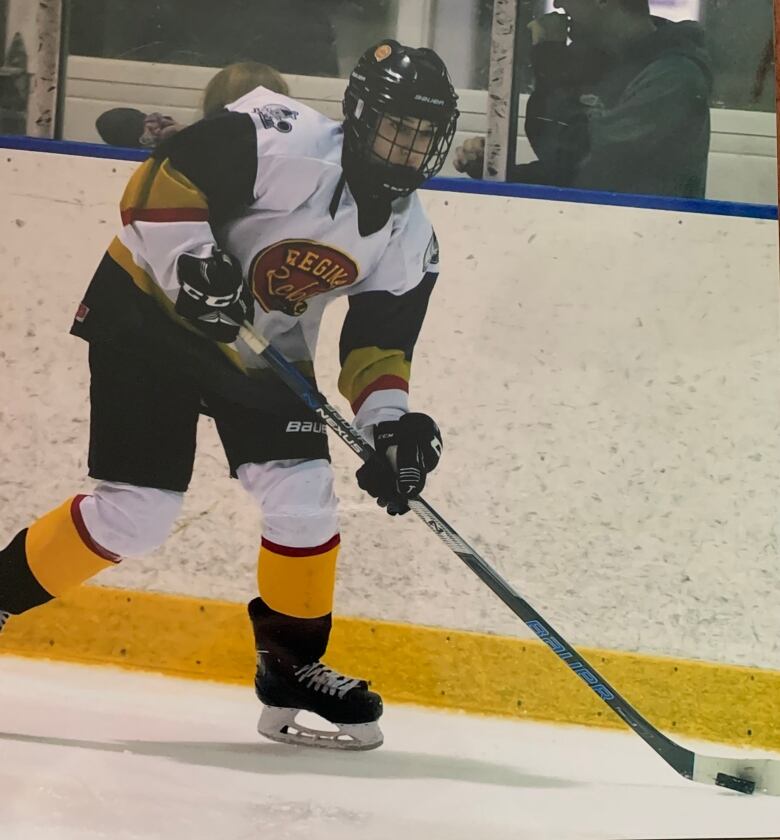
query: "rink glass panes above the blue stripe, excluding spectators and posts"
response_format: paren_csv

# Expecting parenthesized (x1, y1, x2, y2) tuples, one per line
(0, 0, 776, 203)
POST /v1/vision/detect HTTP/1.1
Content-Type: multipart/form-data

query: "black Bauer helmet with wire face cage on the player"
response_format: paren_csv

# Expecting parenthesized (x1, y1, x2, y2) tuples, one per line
(342, 39, 458, 198)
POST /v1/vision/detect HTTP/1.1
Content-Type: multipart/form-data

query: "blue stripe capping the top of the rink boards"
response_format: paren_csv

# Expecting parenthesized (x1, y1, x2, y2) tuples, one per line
(0, 135, 777, 219)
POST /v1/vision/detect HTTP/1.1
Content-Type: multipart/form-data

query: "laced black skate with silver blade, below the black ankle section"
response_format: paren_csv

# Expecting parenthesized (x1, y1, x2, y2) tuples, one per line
(255, 653, 383, 750)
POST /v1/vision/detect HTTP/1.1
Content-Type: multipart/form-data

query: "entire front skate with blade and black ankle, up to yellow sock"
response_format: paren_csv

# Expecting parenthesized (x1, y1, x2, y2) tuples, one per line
(249, 598, 383, 750)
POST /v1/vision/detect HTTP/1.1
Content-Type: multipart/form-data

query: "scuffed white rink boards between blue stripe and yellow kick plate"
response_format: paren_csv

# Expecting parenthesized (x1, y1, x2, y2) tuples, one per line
(0, 151, 780, 668)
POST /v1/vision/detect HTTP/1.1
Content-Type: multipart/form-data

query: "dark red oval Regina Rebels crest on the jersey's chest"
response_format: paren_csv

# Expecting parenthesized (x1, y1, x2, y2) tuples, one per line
(249, 239, 359, 316)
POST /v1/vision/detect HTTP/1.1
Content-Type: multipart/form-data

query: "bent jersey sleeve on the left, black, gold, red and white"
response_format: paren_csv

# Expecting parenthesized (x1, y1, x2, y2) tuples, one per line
(114, 112, 258, 298)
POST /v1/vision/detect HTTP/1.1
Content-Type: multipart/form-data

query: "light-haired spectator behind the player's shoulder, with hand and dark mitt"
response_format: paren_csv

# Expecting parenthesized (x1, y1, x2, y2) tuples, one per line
(95, 61, 289, 149)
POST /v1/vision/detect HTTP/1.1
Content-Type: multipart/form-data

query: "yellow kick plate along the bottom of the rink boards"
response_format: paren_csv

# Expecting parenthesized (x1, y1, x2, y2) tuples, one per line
(0, 586, 780, 750)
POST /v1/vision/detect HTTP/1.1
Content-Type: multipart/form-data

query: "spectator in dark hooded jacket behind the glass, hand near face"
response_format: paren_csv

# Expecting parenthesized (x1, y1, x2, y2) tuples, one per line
(454, 0, 712, 198)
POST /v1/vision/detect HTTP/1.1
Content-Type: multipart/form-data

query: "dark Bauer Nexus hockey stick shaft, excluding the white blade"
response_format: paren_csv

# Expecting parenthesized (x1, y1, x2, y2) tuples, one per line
(239, 324, 695, 779)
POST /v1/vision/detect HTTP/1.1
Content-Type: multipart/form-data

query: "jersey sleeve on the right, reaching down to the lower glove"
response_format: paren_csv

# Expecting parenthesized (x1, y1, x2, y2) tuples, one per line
(339, 199, 439, 429)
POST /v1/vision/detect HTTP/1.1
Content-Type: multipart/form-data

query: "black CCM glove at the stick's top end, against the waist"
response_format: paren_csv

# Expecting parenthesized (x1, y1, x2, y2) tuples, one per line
(176, 248, 253, 344)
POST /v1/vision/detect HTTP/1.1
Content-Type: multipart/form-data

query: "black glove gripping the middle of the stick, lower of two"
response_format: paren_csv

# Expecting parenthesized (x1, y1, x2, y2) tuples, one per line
(357, 413, 442, 516)
